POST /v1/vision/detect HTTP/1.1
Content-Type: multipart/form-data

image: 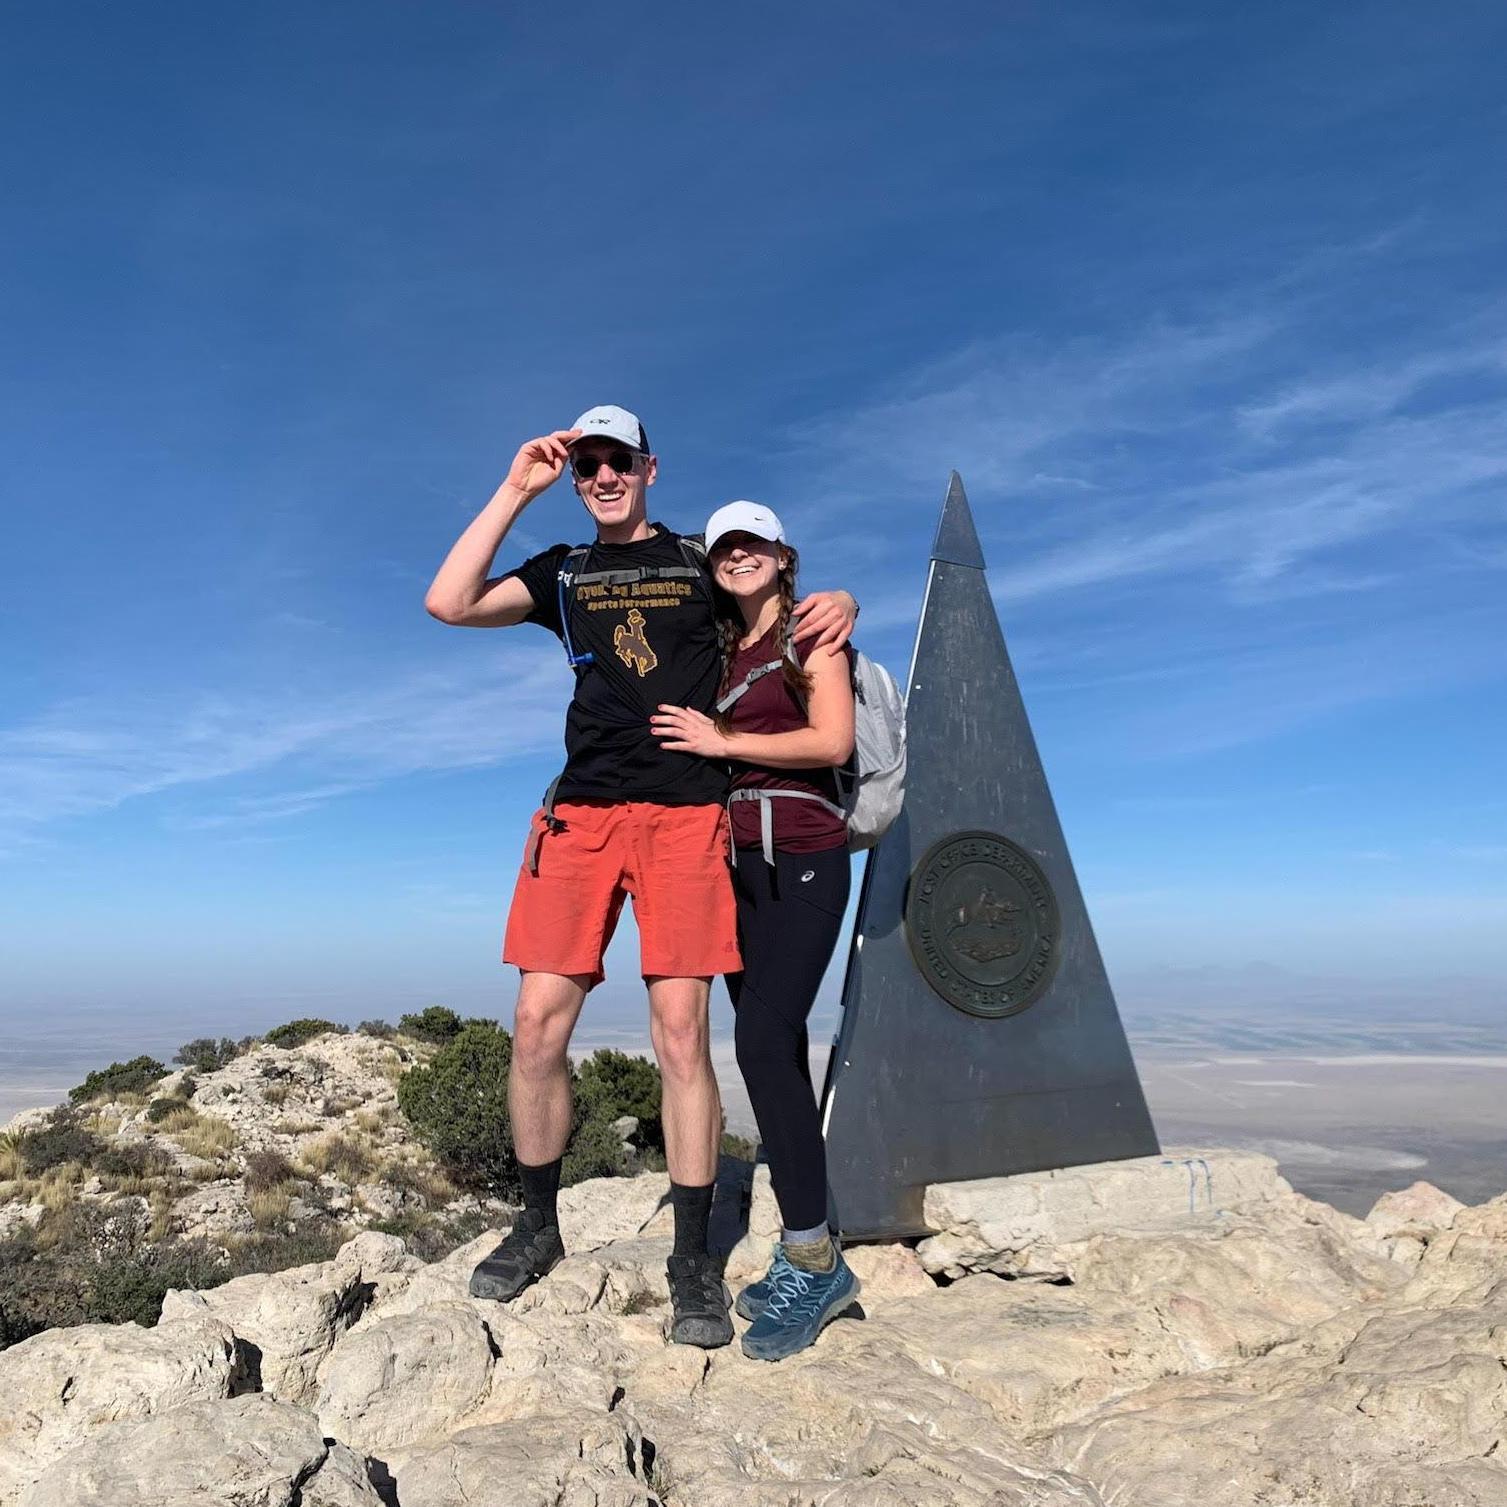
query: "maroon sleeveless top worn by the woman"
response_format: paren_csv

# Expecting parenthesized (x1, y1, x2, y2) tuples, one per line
(728, 625, 853, 853)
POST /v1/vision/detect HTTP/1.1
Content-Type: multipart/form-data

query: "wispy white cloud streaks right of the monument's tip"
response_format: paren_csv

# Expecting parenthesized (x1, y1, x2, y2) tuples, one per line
(793, 288, 1507, 614)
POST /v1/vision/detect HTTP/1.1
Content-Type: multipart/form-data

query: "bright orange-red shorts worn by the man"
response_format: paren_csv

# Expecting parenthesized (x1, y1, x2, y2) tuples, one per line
(502, 800, 743, 987)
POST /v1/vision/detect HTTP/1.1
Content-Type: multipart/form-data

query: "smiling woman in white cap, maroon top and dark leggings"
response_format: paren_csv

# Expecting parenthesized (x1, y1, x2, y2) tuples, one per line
(651, 502, 859, 1361)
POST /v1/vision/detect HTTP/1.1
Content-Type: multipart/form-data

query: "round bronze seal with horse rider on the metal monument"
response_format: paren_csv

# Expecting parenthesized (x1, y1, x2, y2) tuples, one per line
(906, 832, 1061, 1019)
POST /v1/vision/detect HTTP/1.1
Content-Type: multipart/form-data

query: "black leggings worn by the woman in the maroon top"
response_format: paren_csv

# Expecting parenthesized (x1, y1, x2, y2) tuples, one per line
(728, 847, 850, 1230)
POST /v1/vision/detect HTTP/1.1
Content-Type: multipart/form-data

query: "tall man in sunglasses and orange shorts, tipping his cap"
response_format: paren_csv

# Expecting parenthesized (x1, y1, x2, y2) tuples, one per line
(425, 405, 856, 1347)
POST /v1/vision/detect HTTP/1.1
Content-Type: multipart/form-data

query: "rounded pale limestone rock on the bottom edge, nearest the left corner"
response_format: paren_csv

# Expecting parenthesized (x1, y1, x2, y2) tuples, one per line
(18, 1397, 381, 1507)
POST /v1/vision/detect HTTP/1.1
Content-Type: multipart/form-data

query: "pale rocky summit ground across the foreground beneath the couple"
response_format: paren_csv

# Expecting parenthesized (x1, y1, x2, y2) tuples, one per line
(0, 1150, 1507, 1507)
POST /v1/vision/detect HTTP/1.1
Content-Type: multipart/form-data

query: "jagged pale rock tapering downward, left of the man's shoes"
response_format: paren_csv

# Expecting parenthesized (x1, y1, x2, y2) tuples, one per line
(163, 1233, 416, 1403)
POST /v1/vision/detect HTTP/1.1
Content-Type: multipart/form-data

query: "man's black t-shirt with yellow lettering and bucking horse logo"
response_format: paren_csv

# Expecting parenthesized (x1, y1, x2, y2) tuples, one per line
(508, 523, 728, 806)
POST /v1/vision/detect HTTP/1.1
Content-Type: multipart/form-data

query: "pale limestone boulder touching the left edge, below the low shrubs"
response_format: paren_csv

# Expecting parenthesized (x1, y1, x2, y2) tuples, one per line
(0, 1313, 246, 1507)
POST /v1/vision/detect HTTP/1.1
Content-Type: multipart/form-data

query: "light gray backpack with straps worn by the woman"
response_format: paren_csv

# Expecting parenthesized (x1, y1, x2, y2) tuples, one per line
(717, 643, 906, 864)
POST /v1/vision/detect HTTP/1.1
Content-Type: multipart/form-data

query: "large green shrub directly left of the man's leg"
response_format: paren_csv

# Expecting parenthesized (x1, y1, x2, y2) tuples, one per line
(398, 1025, 521, 1197)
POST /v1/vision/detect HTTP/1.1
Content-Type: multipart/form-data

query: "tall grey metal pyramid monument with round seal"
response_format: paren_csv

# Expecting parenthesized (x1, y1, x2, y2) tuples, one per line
(823, 472, 1159, 1237)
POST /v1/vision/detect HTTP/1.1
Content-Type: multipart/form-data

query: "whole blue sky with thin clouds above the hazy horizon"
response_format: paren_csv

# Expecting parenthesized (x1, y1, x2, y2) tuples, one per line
(0, 0, 1507, 1032)
